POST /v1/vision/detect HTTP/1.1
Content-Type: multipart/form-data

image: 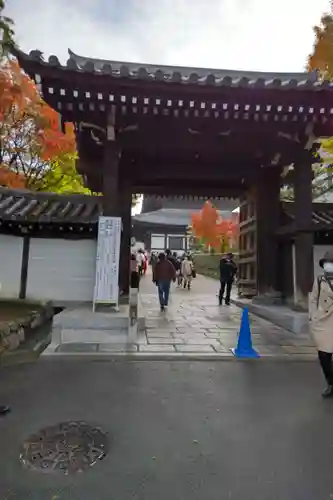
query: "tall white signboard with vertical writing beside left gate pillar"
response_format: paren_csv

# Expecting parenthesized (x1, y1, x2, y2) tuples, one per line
(93, 216, 121, 311)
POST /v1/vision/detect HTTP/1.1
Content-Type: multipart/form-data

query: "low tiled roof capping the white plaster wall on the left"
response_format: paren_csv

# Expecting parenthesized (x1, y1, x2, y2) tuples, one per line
(0, 187, 102, 224)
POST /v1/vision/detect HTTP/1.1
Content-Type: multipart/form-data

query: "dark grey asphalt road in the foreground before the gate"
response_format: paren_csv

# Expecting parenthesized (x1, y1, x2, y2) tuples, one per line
(0, 360, 333, 500)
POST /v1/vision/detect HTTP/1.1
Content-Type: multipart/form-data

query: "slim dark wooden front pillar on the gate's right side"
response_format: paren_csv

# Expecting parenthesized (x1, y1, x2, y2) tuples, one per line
(294, 152, 313, 310)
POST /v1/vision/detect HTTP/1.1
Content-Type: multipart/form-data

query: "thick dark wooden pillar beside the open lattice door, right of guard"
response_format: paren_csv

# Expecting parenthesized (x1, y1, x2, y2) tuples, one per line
(256, 166, 281, 301)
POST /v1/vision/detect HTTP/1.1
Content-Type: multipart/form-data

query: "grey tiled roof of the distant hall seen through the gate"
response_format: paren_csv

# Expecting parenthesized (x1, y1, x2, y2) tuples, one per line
(133, 208, 232, 227)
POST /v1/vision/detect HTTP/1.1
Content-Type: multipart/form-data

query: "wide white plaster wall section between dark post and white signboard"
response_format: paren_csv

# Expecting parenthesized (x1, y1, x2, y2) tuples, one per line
(27, 238, 97, 303)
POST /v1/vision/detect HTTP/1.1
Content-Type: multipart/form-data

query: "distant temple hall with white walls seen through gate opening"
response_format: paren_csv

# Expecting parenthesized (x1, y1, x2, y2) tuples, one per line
(132, 195, 238, 253)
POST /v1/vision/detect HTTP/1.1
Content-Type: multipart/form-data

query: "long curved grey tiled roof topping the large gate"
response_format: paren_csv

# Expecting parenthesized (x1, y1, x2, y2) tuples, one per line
(15, 49, 324, 90)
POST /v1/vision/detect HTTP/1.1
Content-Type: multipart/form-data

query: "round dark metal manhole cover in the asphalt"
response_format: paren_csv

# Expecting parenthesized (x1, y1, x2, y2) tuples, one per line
(20, 422, 108, 474)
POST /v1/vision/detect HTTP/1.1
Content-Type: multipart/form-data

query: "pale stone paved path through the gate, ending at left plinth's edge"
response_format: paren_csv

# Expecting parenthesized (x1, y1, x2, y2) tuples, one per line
(134, 275, 316, 359)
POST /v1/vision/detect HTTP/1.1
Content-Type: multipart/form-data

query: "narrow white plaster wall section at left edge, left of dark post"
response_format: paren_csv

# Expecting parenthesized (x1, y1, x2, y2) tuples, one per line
(0, 234, 23, 298)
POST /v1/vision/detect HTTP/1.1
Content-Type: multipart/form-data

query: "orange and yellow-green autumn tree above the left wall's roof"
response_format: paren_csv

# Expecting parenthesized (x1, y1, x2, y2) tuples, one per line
(0, 60, 90, 193)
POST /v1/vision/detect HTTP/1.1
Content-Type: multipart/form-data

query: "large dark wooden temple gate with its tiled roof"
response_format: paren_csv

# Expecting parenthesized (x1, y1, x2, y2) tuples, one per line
(16, 51, 333, 307)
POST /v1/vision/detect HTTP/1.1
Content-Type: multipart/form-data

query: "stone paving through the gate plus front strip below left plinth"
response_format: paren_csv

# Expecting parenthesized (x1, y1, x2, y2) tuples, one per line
(48, 274, 317, 361)
